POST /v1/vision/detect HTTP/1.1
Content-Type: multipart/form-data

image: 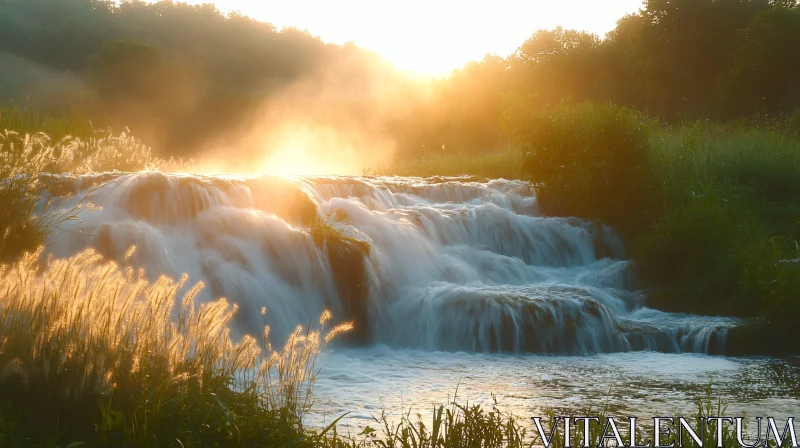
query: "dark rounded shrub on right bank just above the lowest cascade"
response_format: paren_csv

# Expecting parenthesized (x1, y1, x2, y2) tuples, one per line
(631, 196, 761, 315)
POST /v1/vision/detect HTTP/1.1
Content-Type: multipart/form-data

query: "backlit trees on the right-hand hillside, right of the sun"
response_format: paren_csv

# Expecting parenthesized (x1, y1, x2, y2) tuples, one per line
(410, 0, 800, 156)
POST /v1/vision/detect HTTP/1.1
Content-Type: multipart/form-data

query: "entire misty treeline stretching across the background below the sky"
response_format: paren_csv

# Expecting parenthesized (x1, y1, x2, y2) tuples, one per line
(0, 0, 800, 161)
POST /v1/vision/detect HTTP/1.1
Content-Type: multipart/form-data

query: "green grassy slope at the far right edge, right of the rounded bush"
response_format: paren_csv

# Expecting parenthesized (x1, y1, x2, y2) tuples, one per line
(633, 122, 800, 325)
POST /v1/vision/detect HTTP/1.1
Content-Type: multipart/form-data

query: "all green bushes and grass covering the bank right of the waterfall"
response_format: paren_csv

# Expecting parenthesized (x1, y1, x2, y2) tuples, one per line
(410, 103, 800, 330)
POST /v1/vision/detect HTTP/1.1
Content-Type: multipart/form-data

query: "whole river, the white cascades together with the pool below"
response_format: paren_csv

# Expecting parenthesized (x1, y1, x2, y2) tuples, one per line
(42, 172, 800, 426)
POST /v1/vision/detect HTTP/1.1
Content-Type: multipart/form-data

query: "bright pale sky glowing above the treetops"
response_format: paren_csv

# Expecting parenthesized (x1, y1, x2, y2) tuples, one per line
(175, 0, 642, 75)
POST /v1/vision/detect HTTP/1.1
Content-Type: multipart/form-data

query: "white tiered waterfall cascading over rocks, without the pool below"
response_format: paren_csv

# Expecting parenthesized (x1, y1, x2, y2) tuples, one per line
(42, 172, 736, 355)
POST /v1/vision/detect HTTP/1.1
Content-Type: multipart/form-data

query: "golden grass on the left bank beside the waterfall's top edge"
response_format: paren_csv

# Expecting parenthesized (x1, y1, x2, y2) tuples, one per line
(0, 107, 193, 262)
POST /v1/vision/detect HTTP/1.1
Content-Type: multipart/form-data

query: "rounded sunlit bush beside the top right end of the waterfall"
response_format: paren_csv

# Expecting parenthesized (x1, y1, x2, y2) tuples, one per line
(508, 103, 654, 234)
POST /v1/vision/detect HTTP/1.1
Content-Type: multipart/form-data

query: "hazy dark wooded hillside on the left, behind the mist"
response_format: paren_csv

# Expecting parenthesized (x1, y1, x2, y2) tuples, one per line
(0, 0, 341, 156)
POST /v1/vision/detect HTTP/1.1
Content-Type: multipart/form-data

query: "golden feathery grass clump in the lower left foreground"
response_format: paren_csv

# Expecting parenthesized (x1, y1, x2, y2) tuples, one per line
(0, 250, 350, 446)
